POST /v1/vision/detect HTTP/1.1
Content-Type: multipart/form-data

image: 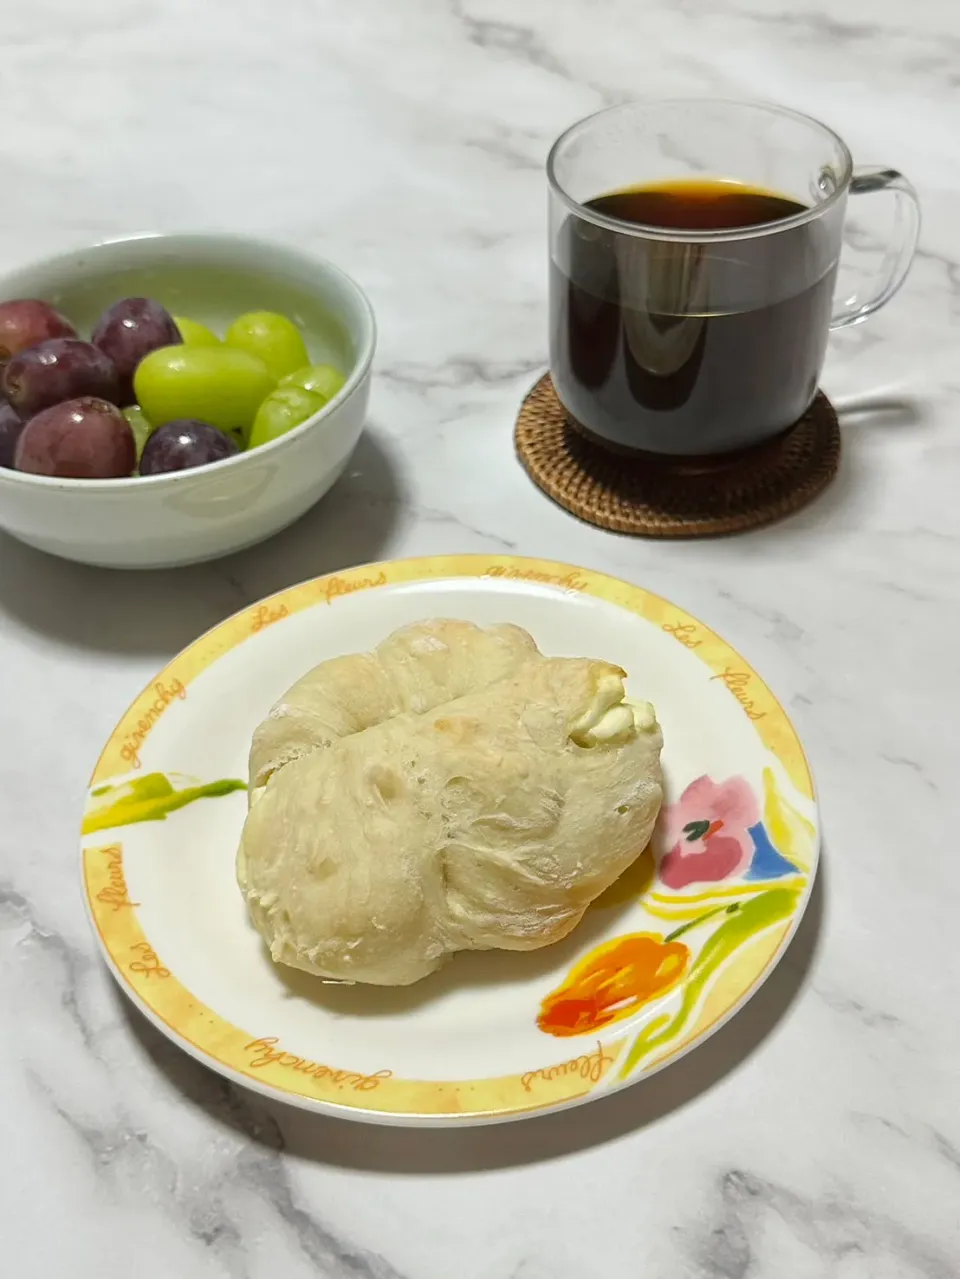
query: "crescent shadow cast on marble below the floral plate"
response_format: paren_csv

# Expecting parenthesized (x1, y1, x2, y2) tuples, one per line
(115, 849, 827, 1174)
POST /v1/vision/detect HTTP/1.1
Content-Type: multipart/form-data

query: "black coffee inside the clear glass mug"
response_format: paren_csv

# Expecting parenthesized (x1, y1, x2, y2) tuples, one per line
(551, 180, 836, 455)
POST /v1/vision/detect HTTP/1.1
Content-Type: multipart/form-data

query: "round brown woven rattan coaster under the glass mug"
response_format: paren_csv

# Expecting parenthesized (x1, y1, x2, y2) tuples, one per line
(514, 373, 840, 537)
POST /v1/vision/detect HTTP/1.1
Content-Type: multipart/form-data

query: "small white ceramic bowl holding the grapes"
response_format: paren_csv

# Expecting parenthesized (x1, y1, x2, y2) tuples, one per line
(0, 235, 376, 568)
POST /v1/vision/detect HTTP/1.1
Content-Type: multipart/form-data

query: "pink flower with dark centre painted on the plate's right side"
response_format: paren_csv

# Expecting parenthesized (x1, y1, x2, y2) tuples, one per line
(660, 778, 761, 889)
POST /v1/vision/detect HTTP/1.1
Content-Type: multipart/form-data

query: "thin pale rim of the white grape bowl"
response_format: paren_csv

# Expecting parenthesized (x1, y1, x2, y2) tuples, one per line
(0, 230, 377, 494)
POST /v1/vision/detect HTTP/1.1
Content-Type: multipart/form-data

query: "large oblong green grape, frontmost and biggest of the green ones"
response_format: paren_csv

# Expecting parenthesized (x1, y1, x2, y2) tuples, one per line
(133, 343, 275, 432)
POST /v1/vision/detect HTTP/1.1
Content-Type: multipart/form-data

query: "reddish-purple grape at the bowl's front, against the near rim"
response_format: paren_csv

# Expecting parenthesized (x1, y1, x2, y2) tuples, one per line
(14, 395, 137, 480)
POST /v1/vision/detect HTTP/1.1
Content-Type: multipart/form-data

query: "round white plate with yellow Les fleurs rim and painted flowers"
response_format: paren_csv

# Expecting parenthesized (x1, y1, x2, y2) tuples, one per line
(82, 555, 818, 1124)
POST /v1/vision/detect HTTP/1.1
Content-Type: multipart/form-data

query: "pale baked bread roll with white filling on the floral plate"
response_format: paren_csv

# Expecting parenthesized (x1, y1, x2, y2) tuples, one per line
(238, 620, 662, 986)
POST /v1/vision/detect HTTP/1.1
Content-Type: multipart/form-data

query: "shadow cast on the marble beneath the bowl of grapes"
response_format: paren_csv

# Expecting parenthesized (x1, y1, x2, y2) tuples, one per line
(0, 430, 405, 661)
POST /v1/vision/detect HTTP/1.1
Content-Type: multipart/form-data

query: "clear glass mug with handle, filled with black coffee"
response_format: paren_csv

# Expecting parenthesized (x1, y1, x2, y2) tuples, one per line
(547, 100, 920, 457)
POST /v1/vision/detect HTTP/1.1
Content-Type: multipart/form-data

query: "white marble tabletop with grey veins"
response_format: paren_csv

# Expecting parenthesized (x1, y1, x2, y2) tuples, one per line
(0, 0, 960, 1279)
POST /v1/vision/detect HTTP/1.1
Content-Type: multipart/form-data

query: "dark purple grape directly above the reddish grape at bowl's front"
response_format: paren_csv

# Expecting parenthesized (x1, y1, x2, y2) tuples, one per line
(3, 338, 118, 418)
